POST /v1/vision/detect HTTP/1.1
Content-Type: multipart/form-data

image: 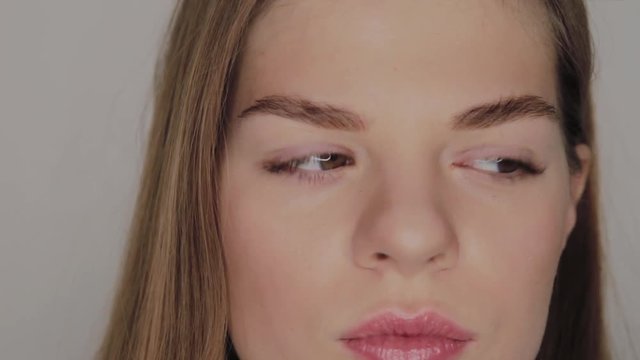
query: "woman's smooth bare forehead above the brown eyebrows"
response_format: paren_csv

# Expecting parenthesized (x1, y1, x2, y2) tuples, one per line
(231, 0, 555, 122)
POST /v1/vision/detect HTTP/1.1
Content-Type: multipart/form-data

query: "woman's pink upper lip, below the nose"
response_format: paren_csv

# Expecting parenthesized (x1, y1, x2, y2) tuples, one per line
(341, 311, 473, 341)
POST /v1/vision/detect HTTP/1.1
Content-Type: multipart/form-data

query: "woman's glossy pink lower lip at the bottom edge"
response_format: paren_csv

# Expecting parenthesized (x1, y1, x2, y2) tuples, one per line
(344, 335, 467, 360)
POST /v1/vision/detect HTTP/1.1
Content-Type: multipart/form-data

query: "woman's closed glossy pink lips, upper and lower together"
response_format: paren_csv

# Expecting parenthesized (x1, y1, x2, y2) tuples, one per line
(340, 311, 473, 360)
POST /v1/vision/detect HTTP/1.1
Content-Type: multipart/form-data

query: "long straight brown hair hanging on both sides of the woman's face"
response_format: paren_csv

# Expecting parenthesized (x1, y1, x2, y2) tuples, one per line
(97, 0, 608, 360)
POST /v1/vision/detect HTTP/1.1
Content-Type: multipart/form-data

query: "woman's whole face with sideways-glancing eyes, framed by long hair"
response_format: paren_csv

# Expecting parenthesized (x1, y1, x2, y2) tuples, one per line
(220, 0, 588, 360)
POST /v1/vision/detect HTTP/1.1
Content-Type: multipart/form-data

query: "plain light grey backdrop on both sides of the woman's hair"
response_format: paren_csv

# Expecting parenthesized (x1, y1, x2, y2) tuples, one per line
(0, 0, 640, 360)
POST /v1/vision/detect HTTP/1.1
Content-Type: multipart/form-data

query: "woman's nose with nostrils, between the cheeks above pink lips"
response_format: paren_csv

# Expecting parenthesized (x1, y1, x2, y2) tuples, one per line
(352, 173, 458, 277)
